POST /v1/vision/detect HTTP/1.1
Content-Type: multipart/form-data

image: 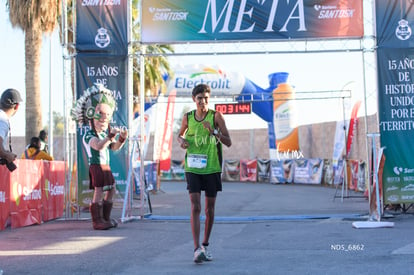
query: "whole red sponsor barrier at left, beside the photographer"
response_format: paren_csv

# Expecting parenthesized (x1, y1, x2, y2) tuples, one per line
(0, 159, 65, 230)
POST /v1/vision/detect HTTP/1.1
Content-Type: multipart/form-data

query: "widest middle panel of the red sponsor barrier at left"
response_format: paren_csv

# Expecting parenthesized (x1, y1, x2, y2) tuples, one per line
(10, 160, 44, 228)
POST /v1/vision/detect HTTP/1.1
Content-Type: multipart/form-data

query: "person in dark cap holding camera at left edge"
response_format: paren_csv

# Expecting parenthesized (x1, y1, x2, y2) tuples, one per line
(0, 89, 23, 171)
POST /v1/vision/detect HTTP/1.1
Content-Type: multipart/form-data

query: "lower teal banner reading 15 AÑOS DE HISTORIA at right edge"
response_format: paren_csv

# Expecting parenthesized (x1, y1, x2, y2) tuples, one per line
(377, 48, 414, 204)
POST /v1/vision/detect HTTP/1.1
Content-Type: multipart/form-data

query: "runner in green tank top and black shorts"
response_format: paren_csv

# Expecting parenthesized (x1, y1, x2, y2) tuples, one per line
(178, 84, 231, 263)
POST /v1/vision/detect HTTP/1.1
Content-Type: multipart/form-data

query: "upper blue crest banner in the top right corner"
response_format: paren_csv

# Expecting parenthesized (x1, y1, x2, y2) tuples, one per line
(375, 0, 414, 48)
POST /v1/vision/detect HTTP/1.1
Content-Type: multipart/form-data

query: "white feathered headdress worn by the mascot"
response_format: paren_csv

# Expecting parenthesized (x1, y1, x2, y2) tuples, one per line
(71, 84, 116, 126)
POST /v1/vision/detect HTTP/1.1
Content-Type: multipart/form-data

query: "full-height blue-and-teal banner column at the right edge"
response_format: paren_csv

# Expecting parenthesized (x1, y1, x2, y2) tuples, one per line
(376, 0, 414, 204)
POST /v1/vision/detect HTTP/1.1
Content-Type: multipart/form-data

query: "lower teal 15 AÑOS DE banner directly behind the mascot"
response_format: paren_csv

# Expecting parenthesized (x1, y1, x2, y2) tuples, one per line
(76, 54, 129, 206)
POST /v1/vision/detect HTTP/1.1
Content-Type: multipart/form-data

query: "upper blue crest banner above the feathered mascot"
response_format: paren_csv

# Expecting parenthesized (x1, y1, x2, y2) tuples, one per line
(76, 0, 128, 55)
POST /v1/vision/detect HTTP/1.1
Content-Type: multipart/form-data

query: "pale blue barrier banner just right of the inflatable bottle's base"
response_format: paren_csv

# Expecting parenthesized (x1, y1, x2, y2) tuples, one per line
(293, 159, 323, 184)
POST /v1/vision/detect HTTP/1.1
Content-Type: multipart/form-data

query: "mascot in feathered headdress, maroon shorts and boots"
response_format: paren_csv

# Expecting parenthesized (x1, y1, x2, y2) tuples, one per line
(72, 84, 128, 230)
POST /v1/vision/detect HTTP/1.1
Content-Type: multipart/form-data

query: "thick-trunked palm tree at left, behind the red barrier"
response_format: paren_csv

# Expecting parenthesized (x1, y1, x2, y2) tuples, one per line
(6, 0, 61, 143)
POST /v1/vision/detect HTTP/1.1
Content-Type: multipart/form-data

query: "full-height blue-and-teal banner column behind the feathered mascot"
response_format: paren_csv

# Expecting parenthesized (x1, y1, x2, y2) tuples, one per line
(76, 0, 130, 206)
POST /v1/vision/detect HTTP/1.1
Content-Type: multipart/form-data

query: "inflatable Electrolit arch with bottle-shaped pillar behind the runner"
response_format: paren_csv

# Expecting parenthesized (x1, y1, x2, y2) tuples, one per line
(168, 64, 299, 155)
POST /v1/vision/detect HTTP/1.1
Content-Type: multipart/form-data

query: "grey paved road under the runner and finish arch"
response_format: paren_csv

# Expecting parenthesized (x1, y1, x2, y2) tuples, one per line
(0, 182, 414, 274)
